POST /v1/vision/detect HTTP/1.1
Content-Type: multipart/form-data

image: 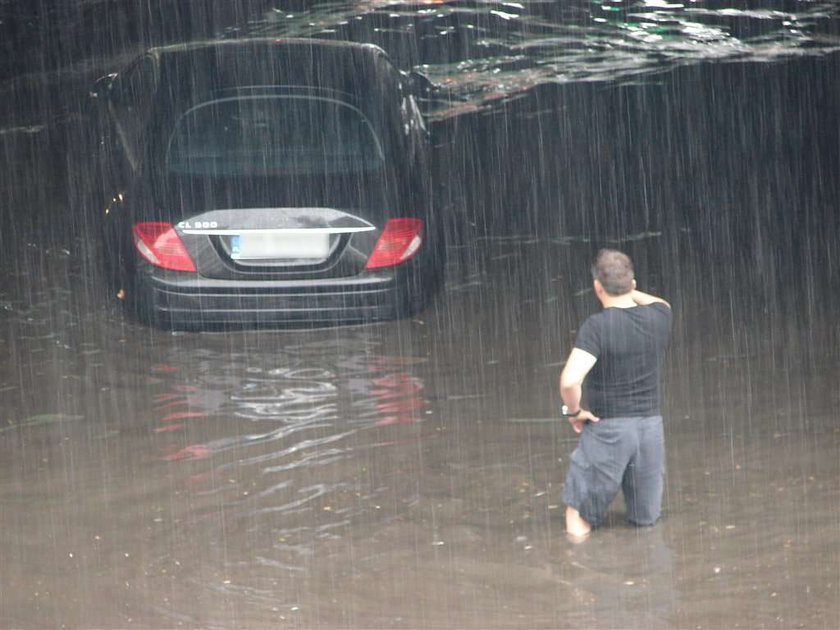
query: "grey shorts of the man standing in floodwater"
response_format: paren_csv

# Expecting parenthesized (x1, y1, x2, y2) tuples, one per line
(563, 416, 665, 527)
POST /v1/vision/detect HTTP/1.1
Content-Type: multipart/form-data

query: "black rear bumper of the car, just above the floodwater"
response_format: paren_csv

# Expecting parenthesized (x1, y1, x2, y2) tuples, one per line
(136, 270, 430, 328)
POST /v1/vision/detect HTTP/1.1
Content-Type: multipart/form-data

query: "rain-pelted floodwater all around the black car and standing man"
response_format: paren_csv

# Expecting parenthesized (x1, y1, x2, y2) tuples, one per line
(0, 0, 840, 628)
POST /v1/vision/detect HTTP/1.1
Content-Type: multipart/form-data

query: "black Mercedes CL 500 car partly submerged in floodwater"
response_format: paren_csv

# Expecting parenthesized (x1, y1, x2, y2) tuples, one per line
(87, 39, 443, 328)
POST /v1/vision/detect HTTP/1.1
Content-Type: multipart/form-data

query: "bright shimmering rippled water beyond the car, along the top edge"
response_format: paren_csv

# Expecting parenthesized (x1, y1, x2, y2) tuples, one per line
(246, 0, 840, 118)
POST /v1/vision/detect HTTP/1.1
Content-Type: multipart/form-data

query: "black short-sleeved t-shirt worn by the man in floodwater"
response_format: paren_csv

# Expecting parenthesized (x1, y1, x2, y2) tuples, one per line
(575, 302, 672, 418)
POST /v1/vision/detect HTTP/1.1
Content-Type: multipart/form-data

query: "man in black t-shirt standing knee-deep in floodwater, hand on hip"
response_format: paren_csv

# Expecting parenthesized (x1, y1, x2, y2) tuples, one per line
(560, 250, 672, 537)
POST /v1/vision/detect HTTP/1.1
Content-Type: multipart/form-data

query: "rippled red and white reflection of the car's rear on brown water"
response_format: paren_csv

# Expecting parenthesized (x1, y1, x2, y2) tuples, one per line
(145, 336, 427, 498)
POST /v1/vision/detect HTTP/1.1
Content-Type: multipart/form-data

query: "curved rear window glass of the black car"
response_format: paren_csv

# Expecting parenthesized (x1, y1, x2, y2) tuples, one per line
(166, 96, 384, 177)
